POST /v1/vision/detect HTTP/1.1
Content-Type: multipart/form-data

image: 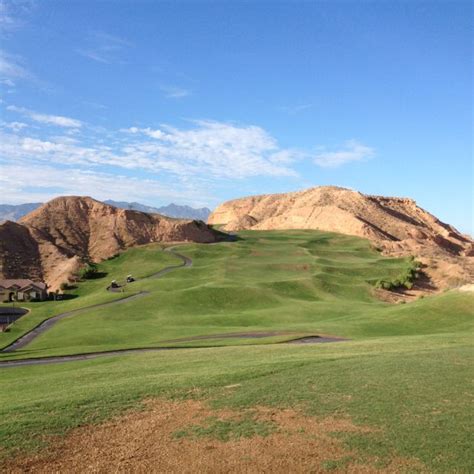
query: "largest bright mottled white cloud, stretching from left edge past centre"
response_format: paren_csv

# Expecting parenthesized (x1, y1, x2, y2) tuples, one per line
(0, 121, 297, 180)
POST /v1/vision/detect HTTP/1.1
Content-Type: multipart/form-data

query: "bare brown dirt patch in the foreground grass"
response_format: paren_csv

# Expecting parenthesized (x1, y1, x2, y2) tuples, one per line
(0, 400, 426, 473)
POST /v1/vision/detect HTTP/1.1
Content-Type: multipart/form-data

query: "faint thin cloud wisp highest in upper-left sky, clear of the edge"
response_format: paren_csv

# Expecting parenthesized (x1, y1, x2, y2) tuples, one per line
(76, 31, 132, 64)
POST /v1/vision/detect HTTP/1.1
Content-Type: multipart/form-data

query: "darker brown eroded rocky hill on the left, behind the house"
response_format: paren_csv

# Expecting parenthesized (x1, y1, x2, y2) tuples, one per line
(0, 196, 222, 289)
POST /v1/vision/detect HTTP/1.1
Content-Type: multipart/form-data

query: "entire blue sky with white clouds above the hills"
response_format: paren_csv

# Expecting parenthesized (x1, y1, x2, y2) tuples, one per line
(0, 0, 473, 233)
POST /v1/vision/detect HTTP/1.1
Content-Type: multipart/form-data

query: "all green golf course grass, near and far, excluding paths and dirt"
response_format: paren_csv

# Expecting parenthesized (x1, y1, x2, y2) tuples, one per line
(0, 231, 474, 472)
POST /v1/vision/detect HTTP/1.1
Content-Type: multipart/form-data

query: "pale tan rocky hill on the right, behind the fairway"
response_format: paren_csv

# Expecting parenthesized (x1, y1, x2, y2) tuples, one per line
(208, 186, 474, 288)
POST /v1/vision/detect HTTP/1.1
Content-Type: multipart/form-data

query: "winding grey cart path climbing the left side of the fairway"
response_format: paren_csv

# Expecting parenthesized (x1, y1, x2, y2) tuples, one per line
(0, 248, 193, 352)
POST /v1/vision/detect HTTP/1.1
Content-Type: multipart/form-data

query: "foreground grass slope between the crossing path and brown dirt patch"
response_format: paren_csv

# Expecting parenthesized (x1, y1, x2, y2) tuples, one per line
(0, 334, 474, 473)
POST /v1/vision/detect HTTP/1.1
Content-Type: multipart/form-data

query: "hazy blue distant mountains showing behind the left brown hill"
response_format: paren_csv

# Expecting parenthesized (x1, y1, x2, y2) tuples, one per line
(0, 199, 211, 222)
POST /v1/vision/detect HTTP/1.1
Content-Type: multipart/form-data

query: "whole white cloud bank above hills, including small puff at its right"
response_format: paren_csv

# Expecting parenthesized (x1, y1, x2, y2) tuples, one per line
(0, 113, 374, 205)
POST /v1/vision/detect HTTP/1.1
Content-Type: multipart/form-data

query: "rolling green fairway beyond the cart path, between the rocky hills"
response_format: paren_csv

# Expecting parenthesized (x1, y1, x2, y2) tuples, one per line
(0, 231, 472, 359)
